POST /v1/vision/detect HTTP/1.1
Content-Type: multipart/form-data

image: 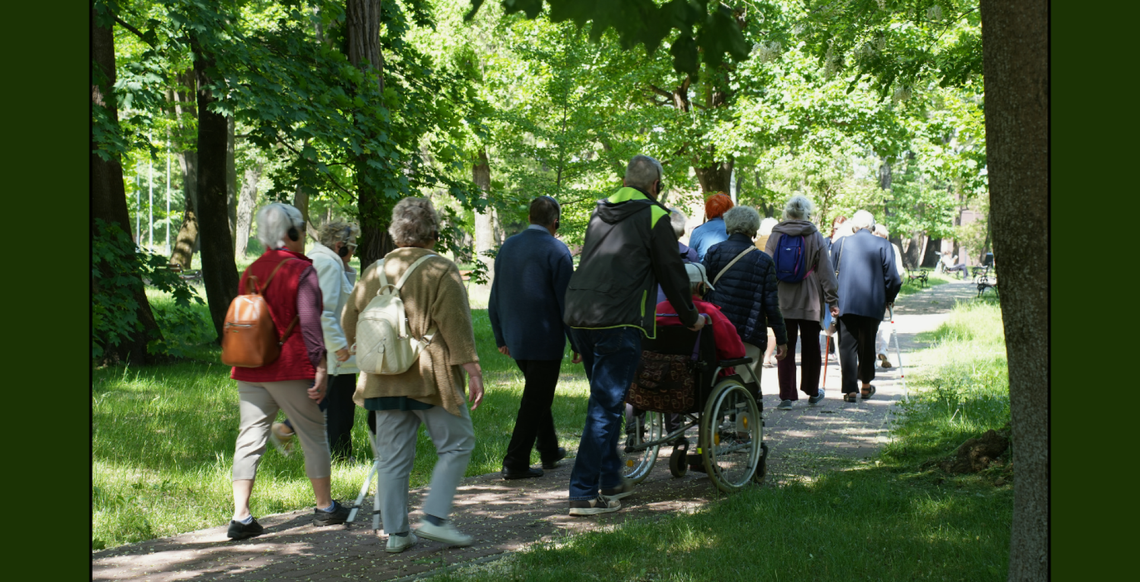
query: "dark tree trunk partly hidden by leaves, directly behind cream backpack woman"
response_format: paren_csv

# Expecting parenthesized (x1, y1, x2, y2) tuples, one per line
(345, 0, 396, 269)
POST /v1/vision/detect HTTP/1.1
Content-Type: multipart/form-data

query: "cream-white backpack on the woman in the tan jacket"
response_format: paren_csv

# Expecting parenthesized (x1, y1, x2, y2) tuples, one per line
(352, 255, 435, 376)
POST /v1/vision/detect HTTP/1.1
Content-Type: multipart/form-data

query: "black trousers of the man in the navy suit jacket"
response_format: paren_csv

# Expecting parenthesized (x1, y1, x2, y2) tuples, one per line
(503, 360, 562, 470)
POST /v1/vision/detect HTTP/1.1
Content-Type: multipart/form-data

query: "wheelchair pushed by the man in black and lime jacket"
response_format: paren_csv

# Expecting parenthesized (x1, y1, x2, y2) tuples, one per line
(618, 326, 768, 492)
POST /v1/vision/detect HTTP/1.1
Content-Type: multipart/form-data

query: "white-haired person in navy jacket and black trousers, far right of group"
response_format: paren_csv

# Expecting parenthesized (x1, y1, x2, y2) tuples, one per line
(831, 211, 903, 402)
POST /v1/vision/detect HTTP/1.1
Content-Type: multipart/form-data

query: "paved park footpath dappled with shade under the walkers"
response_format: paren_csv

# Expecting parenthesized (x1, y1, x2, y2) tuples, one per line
(91, 281, 977, 582)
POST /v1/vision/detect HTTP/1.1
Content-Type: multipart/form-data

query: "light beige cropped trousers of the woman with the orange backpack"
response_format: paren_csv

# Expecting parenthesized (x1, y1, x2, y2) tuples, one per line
(234, 380, 333, 481)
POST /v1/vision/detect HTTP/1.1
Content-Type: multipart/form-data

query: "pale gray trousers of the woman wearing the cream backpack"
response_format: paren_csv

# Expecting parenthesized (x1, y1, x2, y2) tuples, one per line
(376, 405, 475, 534)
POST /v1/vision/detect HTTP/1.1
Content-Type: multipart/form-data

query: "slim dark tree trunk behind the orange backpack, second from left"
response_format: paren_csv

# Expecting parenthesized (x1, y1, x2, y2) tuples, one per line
(190, 36, 238, 342)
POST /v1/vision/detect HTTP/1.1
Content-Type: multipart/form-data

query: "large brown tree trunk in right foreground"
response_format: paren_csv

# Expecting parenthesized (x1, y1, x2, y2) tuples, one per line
(982, 0, 1049, 581)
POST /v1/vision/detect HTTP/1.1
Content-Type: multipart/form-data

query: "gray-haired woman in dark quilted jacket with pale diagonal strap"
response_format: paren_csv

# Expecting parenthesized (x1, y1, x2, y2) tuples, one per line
(701, 206, 788, 389)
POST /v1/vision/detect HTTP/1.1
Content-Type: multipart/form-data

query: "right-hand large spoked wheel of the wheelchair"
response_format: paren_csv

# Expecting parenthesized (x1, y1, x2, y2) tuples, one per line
(700, 379, 764, 492)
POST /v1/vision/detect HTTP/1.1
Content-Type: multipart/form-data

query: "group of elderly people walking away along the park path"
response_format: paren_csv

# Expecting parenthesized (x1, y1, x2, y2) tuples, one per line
(220, 156, 902, 552)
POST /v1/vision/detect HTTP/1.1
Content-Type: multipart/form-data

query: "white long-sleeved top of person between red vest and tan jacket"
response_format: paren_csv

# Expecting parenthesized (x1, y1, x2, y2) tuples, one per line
(307, 243, 360, 375)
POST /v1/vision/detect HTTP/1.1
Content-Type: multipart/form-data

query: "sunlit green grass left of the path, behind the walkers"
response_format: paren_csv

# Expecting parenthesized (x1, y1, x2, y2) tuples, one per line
(91, 305, 588, 549)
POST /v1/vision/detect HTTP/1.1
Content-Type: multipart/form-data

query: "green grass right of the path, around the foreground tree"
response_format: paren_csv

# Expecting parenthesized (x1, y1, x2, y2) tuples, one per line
(437, 303, 1012, 582)
